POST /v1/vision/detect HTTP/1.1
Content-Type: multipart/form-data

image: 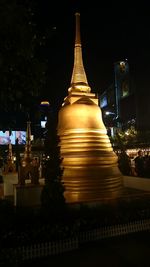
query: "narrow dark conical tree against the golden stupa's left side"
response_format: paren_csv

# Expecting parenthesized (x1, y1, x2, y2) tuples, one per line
(41, 112, 65, 215)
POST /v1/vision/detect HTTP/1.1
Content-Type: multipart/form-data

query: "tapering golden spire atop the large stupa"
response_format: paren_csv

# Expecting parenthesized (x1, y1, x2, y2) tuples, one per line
(69, 13, 91, 93)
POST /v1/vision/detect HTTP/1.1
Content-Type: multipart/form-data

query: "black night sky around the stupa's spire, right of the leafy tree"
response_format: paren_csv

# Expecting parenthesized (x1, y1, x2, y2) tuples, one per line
(35, 0, 150, 108)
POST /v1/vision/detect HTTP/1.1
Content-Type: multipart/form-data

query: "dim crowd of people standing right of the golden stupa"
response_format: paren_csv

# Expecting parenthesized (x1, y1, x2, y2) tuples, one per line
(118, 150, 150, 178)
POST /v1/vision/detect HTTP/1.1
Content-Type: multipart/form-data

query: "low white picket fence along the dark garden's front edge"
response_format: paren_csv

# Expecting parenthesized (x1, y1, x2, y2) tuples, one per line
(3, 219, 150, 261)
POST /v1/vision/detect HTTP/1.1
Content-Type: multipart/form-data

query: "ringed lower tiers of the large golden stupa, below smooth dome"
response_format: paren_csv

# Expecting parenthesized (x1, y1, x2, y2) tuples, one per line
(60, 129, 123, 203)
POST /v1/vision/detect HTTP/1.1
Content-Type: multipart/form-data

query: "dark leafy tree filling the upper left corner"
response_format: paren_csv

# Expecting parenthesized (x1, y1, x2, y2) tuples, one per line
(0, 0, 47, 128)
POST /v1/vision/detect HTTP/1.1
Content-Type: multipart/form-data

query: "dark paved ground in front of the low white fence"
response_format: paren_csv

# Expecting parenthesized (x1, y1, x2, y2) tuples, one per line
(21, 232, 150, 267)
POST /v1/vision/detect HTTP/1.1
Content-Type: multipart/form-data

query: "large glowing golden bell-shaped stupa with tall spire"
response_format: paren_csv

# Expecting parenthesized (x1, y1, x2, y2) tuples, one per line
(58, 13, 123, 203)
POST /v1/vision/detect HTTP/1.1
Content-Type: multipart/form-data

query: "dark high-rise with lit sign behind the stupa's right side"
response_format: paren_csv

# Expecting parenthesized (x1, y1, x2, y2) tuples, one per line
(100, 60, 137, 133)
